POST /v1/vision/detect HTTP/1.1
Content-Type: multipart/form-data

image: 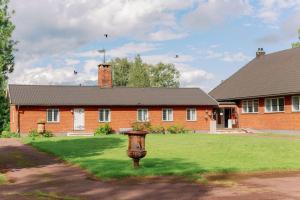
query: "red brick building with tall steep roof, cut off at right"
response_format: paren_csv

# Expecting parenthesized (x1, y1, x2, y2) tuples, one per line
(209, 48, 300, 131)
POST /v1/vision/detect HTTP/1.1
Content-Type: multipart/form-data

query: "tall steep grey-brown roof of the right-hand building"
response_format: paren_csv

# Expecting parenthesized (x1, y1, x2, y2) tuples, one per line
(209, 48, 300, 101)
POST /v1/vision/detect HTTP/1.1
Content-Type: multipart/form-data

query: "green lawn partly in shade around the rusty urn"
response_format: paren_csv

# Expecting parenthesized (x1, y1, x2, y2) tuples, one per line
(25, 134, 300, 179)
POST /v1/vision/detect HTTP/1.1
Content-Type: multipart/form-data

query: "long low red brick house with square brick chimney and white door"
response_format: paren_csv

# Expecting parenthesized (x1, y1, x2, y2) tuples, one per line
(8, 65, 217, 134)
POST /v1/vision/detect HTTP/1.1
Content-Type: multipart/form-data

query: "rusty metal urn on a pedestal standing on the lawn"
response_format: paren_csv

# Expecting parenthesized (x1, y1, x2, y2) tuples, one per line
(126, 131, 148, 168)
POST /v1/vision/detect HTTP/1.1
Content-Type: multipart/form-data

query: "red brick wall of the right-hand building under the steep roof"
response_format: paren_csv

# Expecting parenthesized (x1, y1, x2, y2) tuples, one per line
(239, 96, 300, 130)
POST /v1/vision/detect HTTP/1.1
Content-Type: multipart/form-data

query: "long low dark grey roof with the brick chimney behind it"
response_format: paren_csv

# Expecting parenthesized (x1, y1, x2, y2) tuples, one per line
(8, 85, 217, 106)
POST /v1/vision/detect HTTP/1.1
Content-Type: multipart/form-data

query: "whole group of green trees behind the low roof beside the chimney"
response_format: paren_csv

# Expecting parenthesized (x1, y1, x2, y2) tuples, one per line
(110, 55, 180, 87)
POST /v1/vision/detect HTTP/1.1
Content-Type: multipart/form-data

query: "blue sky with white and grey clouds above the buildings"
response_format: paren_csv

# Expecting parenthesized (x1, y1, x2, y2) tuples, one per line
(9, 0, 300, 92)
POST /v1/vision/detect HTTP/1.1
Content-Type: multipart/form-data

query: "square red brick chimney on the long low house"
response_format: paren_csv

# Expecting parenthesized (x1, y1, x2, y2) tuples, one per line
(98, 64, 112, 88)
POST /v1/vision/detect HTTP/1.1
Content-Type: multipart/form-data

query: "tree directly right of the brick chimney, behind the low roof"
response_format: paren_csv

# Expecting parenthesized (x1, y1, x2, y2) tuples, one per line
(110, 58, 132, 87)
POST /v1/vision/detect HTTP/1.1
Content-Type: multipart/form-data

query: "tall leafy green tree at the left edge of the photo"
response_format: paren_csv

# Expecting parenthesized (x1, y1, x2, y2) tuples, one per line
(0, 0, 16, 131)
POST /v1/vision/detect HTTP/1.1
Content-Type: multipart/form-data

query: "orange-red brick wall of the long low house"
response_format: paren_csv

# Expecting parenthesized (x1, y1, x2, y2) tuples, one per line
(11, 106, 212, 133)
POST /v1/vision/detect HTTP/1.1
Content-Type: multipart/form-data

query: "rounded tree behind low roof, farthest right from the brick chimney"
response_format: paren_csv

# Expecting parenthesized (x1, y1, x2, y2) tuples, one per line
(149, 63, 180, 88)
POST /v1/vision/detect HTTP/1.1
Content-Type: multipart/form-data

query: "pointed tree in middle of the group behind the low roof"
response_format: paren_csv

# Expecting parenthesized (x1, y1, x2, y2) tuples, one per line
(127, 55, 150, 87)
